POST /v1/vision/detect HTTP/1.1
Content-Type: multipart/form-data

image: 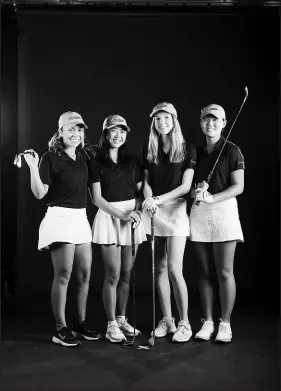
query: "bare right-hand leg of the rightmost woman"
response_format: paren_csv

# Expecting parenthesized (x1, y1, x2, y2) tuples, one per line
(213, 240, 236, 322)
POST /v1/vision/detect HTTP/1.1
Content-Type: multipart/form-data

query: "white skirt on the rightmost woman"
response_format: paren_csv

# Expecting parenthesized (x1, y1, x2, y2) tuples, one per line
(189, 197, 244, 242)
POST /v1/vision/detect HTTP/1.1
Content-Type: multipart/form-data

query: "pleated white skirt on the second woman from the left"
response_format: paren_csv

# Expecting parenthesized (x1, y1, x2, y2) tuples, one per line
(92, 199, 147, 246)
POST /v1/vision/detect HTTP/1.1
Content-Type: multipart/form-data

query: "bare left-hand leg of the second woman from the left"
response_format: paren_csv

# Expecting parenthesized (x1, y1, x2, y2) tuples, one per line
(101, 244, 121, 322)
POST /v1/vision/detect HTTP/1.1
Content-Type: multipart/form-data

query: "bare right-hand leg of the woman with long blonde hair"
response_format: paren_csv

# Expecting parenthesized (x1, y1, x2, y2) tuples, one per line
(167, 236, 188, 320)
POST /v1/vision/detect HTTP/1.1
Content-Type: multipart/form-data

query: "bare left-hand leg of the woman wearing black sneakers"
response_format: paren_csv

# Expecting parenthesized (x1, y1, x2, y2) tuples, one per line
(51, 243, 75, 327)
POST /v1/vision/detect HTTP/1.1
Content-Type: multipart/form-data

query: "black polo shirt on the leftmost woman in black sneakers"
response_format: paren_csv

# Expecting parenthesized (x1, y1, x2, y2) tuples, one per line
(39, 151, 88, 209)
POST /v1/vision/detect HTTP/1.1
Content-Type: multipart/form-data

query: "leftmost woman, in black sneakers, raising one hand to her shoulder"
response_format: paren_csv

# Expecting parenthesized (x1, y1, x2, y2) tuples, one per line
(24, 111, 101, 346)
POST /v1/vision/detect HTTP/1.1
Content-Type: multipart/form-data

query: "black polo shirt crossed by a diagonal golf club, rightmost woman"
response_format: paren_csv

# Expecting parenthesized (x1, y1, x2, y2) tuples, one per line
(194, 137, 245, 194)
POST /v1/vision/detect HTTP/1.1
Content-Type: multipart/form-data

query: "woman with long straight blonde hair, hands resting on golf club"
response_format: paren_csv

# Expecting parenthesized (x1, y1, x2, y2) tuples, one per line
(142, 102, 196, 342)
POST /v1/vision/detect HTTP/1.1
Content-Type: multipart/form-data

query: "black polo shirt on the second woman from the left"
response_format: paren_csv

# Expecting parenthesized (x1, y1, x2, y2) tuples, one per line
(89, 155, 141, 202)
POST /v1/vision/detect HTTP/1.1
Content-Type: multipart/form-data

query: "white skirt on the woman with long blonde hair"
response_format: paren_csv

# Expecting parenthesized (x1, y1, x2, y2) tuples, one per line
(143, 198, 190, 237)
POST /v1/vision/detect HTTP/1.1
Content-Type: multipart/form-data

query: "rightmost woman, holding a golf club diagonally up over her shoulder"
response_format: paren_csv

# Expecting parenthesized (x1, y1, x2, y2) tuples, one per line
(190, 104, 245, 342)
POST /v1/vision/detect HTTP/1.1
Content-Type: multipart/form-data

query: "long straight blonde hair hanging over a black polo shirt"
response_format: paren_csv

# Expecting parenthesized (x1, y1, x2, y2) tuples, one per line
(147, 114, 186, 164)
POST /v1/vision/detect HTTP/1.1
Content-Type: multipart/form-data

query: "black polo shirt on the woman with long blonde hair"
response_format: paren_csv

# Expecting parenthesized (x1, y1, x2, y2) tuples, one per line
(141, 143, 196, 196)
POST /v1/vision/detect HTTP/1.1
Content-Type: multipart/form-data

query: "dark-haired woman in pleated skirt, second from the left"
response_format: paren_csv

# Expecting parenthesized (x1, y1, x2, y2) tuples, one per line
(90, 115, 146, 343)
